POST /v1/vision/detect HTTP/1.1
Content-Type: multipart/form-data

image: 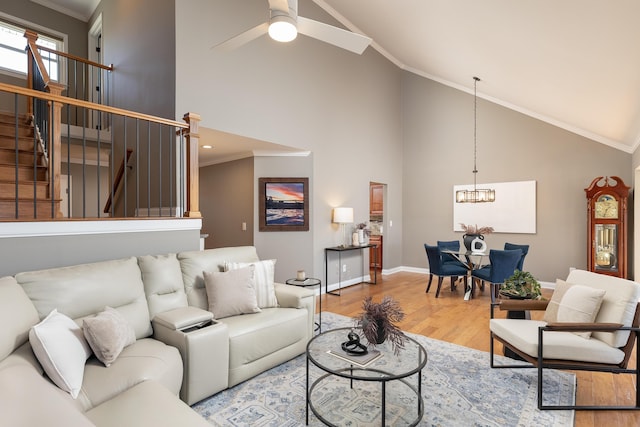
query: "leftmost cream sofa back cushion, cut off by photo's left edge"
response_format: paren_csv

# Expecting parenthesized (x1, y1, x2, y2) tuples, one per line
(0, 277, 40, 361)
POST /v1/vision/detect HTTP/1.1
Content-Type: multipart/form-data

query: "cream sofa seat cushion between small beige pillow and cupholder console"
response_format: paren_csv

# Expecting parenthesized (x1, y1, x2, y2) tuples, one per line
(78, 338, 183, 411)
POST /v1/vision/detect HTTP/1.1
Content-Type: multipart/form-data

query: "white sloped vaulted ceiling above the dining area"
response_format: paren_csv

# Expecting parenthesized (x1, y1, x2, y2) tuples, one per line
(37, 0, 640, 160)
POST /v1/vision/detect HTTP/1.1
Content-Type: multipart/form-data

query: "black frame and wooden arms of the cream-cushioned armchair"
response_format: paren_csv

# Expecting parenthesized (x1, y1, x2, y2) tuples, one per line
(489, 300, 640, 411)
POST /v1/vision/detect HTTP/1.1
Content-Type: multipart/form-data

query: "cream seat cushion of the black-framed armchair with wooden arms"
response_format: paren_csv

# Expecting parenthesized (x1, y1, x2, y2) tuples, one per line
(489, 319, 624, 364)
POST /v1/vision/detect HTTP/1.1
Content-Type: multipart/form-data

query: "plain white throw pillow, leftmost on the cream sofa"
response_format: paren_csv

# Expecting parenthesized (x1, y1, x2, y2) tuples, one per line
(29, 309, 91, 399)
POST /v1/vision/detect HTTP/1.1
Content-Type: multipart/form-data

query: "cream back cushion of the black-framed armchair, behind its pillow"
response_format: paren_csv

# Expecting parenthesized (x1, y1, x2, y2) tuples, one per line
(567, 270, 640, 347)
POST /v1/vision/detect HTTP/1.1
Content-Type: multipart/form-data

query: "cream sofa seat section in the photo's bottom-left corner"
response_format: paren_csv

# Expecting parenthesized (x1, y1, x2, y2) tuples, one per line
(0, 365, 94, 427)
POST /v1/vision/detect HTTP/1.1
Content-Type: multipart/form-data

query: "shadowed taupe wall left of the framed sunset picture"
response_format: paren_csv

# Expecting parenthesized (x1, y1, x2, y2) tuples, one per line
(200, 157, 257, 249)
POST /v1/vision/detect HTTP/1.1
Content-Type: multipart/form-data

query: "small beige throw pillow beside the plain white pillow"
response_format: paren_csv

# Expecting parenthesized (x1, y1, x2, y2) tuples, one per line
(82, 307, 136, 367)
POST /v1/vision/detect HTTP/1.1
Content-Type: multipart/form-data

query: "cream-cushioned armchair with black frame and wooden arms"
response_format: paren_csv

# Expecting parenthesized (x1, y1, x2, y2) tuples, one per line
(489, 270, 640, 411)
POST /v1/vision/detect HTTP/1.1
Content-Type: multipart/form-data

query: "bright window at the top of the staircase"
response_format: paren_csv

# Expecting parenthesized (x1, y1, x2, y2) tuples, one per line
(0, 17, 64, 81)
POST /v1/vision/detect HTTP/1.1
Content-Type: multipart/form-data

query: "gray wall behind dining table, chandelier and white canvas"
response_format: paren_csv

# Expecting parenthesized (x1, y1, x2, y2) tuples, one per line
(403, 73, 633, 281)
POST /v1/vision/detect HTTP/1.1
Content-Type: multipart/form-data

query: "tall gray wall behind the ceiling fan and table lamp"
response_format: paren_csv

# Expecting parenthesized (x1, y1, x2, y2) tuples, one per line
(176, 0, 402, 286)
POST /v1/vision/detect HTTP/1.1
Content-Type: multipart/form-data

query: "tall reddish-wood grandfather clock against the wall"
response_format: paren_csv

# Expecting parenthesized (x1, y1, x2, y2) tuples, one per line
(584, 176, 629, 278)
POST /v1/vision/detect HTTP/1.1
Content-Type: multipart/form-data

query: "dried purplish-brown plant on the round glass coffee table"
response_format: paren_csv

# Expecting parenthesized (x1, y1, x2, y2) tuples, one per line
(355, 295, 406, 355)
